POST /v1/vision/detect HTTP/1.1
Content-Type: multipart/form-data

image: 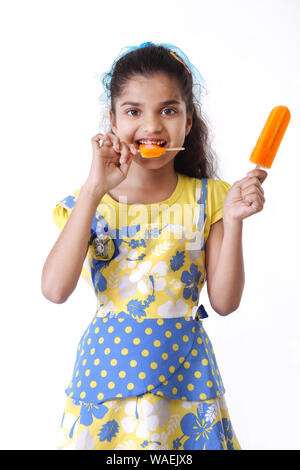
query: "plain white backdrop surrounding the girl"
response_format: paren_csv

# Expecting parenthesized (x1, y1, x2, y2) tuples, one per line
(0, 0, 300, 449)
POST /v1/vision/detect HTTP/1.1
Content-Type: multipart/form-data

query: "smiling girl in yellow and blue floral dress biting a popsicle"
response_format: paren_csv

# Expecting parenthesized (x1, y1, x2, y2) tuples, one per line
(42, 43, 267, 450)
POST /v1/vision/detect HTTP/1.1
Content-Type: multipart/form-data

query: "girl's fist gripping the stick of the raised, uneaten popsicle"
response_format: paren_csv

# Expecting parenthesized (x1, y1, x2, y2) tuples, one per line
(223, 169, 268, 223)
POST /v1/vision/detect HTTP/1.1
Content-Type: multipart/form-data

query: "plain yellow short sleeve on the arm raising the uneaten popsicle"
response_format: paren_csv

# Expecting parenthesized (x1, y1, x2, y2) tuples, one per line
(205, 179, 231, 240)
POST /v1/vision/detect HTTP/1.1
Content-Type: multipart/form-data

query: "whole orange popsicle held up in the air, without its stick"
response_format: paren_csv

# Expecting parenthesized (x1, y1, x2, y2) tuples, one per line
(250, 106, 291, 168)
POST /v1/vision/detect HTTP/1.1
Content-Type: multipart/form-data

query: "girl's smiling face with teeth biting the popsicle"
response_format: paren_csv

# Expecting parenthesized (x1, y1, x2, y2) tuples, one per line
(110, 73, 192, 168)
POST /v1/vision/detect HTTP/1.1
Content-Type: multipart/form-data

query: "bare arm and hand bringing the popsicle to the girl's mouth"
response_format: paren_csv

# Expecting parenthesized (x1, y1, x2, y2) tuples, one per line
(41, 133, 138, 303)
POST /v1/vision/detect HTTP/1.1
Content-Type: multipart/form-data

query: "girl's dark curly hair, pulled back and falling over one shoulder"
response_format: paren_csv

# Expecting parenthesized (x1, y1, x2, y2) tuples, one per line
(102, 45, 217, 178)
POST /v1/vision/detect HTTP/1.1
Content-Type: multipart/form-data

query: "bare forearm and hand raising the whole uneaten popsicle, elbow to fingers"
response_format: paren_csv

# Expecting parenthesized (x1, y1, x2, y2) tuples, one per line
(205, 170, 267, 315)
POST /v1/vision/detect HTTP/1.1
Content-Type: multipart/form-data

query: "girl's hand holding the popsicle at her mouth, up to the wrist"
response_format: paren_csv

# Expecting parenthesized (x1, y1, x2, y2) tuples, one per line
(86, 133, 138, 193)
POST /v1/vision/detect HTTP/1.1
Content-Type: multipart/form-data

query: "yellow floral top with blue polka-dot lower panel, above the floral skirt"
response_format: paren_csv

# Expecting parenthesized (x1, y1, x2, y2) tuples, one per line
(53, 173, 230, 403)
